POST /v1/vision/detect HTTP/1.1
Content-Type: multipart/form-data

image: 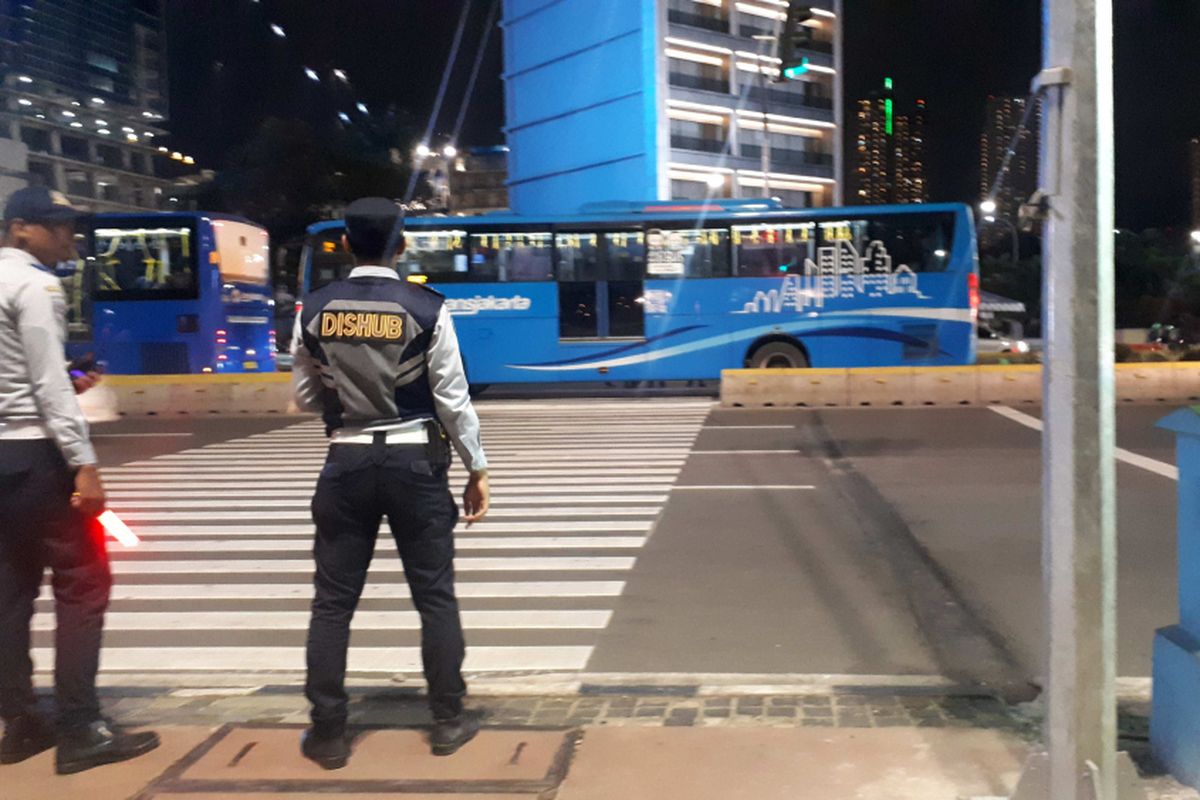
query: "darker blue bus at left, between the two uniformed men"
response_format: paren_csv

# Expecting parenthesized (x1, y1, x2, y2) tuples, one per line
(60, 212, 276, 374)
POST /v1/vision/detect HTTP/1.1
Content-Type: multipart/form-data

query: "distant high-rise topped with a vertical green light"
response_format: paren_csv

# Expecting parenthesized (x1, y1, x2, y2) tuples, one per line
(852, 78, 929, 205)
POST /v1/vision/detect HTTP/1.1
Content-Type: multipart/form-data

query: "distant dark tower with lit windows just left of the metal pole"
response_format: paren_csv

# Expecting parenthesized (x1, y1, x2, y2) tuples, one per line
(979, 96, 1040, 221)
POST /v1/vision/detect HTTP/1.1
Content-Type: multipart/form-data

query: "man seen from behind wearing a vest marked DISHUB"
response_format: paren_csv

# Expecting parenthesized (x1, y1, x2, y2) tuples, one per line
(292, 198, 488, 769)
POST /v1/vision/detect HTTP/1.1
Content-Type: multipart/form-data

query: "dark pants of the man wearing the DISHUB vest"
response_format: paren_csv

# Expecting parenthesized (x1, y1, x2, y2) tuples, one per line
(305, 444, 467, 729)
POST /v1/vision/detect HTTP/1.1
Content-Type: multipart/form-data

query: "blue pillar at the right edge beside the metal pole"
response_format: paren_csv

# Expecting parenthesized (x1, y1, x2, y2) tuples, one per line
(1150, 407, 1200, 788)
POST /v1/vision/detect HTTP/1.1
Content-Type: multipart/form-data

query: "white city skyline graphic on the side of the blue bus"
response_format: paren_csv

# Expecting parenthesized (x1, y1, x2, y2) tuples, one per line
(734, 240, 929, 314)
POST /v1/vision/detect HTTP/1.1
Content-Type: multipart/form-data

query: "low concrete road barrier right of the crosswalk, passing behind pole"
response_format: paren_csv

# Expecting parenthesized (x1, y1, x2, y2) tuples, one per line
(721, 361, 1200, 408)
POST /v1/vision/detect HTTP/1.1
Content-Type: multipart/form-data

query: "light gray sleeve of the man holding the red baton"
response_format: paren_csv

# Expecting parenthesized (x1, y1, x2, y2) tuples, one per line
(16, 278, 96, 467)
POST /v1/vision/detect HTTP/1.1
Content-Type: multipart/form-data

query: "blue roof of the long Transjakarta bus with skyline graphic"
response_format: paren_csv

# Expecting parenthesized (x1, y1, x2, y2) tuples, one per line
(307, 200, 968, 235)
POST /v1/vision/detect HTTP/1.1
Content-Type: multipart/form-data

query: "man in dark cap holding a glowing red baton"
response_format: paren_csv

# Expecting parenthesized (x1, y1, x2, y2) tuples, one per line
(0, 187, 158, 774)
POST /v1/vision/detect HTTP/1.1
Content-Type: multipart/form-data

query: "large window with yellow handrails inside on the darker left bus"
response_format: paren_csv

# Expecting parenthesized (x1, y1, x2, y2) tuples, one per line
(90, 225, 197, 300)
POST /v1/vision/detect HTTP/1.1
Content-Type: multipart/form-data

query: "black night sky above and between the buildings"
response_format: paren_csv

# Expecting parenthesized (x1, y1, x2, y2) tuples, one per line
(167, 0, 1200, 228)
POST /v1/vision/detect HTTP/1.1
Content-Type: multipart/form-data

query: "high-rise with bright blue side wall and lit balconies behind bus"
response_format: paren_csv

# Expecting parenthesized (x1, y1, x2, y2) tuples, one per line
(504, 0, 841, 213)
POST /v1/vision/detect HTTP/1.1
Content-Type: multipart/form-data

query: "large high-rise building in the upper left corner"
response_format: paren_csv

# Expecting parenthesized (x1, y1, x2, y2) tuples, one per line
(0, 0, 197, 211)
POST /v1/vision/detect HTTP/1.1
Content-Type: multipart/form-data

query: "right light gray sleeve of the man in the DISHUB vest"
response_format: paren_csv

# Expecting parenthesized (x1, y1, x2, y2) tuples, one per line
(425, 306, 487, 471)
